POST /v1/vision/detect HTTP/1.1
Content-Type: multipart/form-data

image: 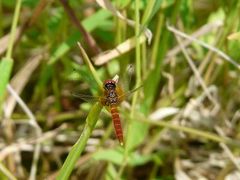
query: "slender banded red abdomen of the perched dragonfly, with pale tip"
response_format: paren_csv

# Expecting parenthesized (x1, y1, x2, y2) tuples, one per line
(110, 106, 123, 145)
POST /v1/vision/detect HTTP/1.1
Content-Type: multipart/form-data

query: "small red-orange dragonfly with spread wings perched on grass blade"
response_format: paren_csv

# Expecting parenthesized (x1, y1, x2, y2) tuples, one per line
(73, 78, 142, 146)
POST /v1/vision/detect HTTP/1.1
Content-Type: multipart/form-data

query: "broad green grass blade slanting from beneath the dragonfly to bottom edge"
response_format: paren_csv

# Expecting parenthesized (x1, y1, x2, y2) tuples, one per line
(57, 103, 102, 180)
